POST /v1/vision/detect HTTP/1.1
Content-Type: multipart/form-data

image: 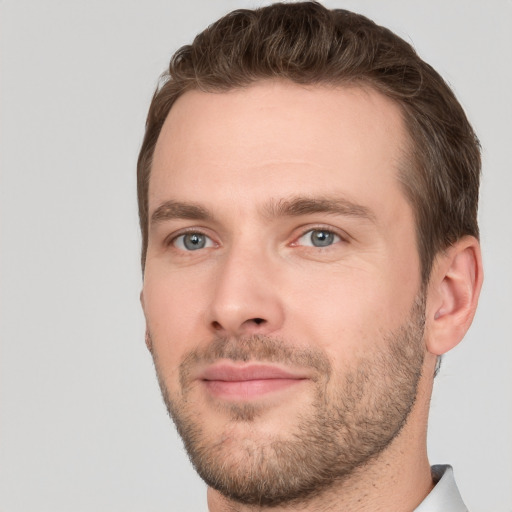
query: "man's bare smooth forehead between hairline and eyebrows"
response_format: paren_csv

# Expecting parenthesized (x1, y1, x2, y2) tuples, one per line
(149, 81, 408, 216)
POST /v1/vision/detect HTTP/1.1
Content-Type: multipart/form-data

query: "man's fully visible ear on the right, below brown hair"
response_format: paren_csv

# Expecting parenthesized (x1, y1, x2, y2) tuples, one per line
(426, 236, 483, 355)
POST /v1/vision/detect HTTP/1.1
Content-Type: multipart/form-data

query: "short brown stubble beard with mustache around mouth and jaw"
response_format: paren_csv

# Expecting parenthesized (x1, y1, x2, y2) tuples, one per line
(155, 295, 425, 507)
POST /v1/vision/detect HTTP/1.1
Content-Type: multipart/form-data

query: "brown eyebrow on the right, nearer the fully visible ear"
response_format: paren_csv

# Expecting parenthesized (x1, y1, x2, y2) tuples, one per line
(264, 197, 376, 223)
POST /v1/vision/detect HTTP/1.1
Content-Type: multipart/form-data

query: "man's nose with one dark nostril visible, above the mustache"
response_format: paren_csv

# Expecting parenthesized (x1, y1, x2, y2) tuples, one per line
(210, 244, 284, 337)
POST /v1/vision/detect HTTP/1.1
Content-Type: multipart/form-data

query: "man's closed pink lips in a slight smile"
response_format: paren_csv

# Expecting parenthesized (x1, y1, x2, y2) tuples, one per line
(199, 363, 308, 401)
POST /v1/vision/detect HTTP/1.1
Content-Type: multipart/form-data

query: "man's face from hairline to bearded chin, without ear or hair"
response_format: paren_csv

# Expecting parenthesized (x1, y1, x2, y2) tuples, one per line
(142, 81, 424, 504)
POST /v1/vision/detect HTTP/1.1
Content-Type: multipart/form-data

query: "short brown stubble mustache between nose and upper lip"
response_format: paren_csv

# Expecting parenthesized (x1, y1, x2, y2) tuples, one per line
(179, 334, 332, 386)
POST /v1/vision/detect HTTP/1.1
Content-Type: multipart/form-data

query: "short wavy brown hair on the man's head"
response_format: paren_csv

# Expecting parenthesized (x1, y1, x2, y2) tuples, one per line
(137, 2, 481, 283)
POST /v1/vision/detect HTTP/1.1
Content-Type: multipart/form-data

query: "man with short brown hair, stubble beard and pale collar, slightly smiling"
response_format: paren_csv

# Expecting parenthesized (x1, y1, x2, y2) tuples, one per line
(138, 2, 482, 512)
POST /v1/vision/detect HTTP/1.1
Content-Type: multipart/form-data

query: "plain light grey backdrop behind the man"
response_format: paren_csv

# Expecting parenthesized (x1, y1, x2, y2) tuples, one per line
(0, 0, 512, 512)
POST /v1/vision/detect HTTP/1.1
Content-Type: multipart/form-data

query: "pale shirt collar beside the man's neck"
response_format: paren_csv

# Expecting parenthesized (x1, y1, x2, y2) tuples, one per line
(414, 466, 468, 512)
